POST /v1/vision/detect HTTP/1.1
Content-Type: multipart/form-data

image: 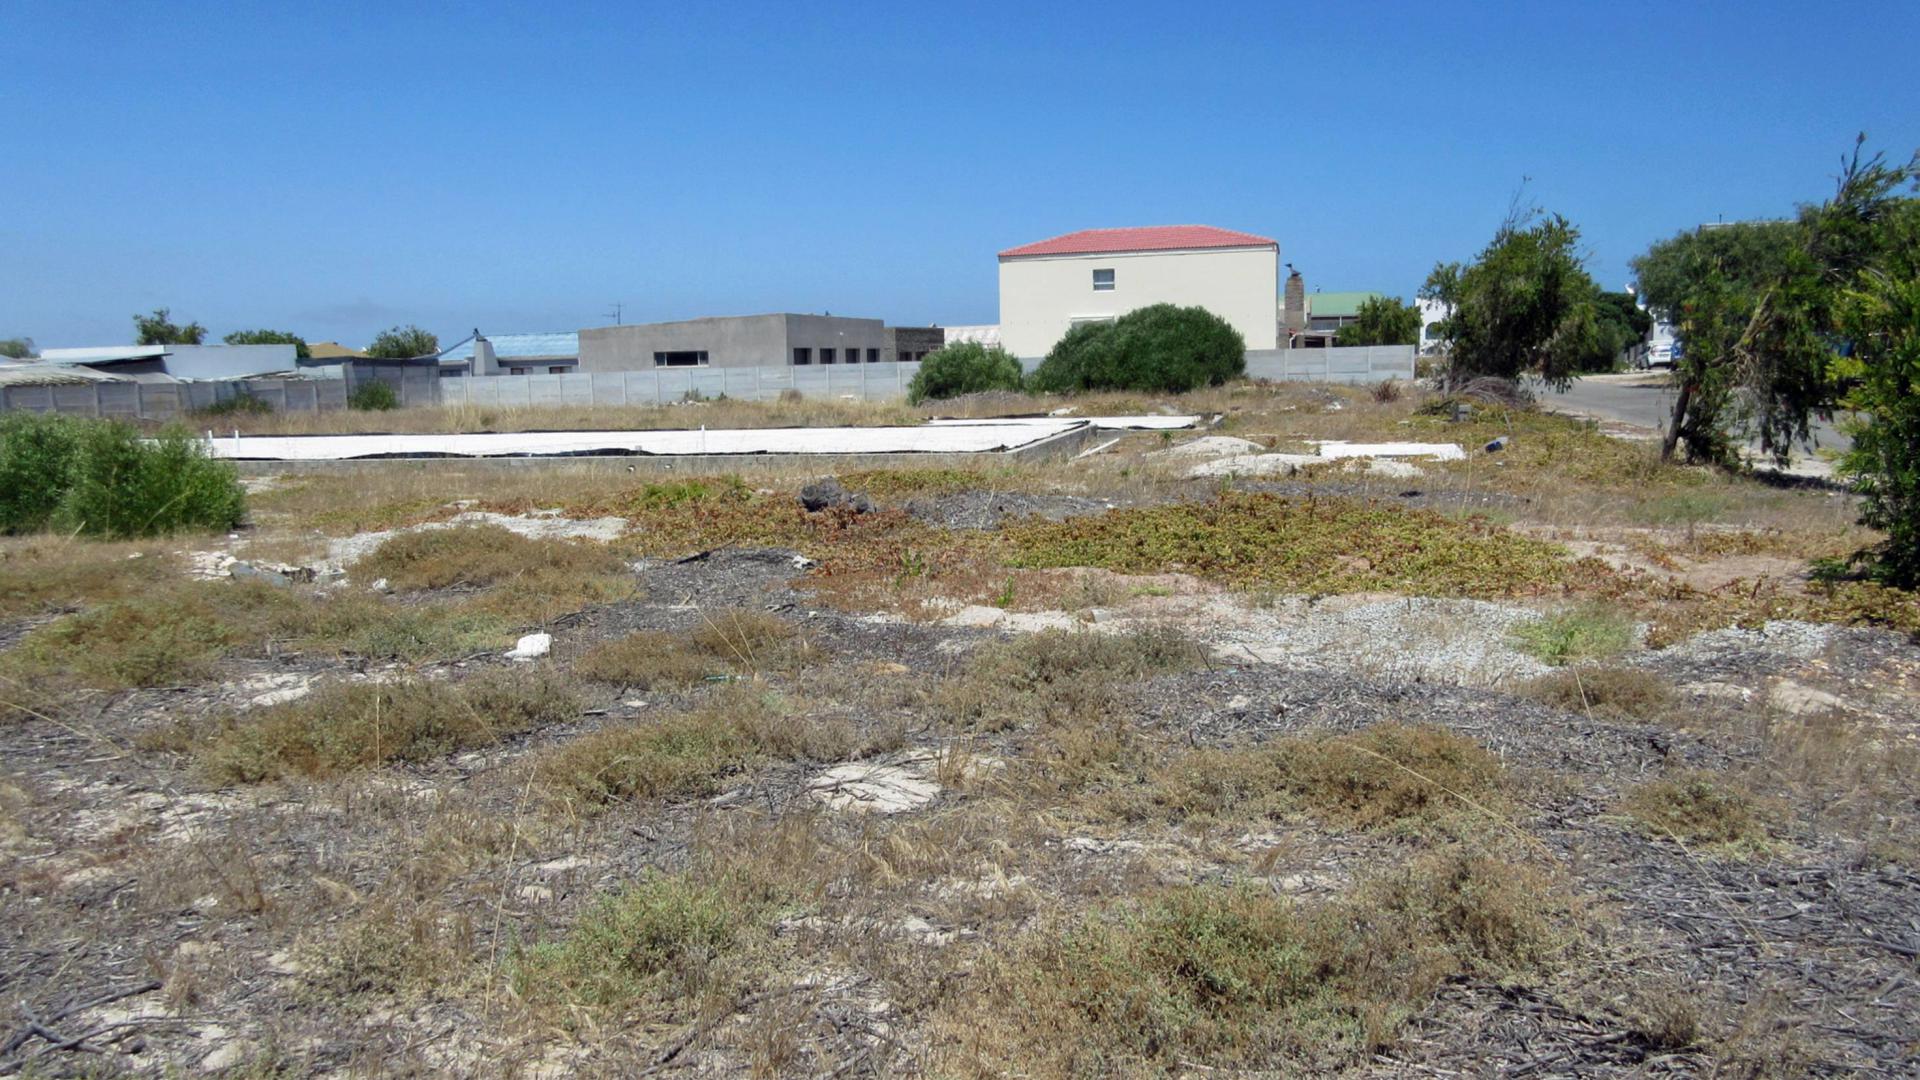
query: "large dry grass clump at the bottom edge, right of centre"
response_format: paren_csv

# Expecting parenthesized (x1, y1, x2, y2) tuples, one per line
(937, 847, 1567, 1076)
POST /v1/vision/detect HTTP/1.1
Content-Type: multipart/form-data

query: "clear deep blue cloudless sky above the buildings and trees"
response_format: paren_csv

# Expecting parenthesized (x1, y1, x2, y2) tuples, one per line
(0, 0, 1920, 346)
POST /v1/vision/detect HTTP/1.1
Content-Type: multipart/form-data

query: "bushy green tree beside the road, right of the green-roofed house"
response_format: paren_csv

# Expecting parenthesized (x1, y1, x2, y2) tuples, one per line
(1421, 208, 1611, 386)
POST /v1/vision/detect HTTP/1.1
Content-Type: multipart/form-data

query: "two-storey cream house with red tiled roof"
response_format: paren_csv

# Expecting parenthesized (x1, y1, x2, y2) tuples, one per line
(1000, 225, 1281, 357)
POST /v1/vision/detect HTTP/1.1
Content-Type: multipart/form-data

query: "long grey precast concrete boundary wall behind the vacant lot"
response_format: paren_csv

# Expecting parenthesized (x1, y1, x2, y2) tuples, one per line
(0, 346, 1413, 427)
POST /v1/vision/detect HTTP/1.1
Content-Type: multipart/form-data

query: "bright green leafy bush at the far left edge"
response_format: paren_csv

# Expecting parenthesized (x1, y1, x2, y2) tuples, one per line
(0, 413, 244, 538)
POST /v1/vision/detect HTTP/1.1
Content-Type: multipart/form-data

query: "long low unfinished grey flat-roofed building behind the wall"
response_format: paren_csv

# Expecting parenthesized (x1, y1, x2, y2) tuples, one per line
(576, 313, 947, 371)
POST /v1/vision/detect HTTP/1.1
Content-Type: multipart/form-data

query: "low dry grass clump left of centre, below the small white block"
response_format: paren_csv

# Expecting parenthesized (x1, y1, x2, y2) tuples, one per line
(196, 669, 580, 782)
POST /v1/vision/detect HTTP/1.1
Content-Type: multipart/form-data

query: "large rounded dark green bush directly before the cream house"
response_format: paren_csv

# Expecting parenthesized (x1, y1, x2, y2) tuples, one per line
(1033, 304, 1246, 394)
